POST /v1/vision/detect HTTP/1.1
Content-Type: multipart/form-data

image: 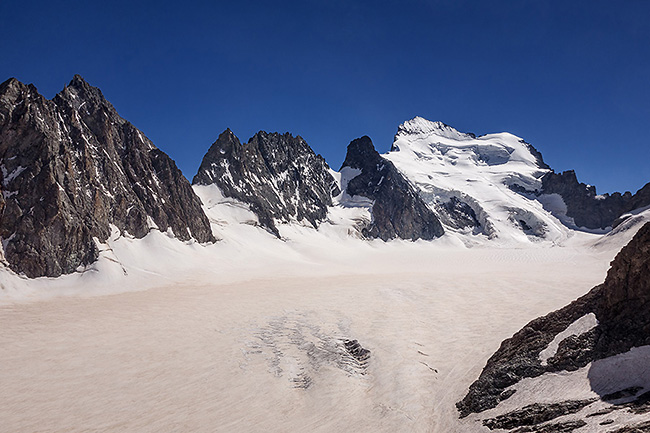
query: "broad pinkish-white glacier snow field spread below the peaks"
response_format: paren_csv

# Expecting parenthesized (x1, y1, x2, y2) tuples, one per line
(0, 187, 634, 432)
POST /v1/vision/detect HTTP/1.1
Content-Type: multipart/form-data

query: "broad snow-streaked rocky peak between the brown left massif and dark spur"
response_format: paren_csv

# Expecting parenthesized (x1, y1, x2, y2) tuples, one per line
(192, 129, 340, 235)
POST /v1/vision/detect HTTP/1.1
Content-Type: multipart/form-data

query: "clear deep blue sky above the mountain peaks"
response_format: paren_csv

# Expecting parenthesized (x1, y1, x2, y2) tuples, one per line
(0, 0, 650, 192)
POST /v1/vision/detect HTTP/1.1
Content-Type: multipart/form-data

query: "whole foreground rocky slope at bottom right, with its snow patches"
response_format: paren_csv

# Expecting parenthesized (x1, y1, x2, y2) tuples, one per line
(457, 223, 650, 431)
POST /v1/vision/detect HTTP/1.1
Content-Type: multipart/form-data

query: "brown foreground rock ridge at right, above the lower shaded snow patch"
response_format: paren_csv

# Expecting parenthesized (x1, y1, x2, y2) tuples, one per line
(457, 223, 650, 426)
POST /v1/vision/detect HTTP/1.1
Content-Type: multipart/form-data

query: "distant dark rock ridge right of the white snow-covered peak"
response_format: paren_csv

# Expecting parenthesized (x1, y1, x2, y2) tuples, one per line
(541, 170, 650, 229)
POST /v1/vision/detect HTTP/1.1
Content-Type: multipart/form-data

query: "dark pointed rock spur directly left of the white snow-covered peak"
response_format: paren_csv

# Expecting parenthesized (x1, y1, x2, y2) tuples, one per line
(341, 136, 444, 240)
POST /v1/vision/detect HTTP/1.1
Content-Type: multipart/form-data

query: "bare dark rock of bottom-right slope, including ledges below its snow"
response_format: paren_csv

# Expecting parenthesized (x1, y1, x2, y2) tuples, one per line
(457, 223, 650, 431)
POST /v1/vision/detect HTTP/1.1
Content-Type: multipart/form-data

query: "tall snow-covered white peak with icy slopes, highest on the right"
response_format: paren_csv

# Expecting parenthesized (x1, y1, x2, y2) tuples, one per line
(384, 117, 571, 243)
